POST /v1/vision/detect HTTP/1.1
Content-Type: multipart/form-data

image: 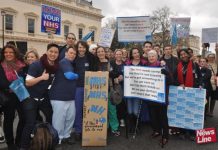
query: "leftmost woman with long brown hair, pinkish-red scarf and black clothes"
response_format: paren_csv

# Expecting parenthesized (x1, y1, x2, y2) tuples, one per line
(0, 44, 25, 150)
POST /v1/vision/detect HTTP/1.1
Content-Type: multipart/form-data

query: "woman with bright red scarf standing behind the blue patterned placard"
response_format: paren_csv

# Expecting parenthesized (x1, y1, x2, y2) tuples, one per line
(174, 49, 202, 141)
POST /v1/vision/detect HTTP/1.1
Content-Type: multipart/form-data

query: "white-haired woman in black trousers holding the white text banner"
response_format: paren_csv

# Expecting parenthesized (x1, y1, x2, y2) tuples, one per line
(147, 50, 171, 146)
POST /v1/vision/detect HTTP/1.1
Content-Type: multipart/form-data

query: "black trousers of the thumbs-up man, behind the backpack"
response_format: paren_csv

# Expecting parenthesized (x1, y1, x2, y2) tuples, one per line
(21, 96, 53, 148)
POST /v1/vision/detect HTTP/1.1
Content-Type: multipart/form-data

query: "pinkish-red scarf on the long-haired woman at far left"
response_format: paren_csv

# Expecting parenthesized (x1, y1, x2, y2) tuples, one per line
(1, 60, 25, 82)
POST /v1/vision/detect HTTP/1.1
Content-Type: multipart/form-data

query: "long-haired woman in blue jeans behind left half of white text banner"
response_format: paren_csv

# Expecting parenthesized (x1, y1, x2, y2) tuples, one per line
(126, 48, 147, 134)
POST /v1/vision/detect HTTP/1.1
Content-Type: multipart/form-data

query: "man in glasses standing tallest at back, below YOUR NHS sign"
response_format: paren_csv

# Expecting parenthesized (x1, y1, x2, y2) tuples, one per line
(58, 33, 76, 60)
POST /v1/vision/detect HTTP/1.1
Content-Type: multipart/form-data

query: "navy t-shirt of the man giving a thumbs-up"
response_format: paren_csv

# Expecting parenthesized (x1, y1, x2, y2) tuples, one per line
(27, 60, 54, 98)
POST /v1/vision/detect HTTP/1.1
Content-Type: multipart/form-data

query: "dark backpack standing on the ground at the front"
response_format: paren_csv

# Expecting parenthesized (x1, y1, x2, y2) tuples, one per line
(30, 123, 59, 150)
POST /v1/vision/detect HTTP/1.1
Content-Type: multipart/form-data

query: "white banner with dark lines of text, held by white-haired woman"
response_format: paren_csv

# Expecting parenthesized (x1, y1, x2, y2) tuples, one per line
(124, 66, 165, 103)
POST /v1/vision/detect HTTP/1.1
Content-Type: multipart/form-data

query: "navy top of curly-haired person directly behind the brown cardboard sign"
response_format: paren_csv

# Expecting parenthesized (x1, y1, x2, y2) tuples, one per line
(75, 56, 90, 87)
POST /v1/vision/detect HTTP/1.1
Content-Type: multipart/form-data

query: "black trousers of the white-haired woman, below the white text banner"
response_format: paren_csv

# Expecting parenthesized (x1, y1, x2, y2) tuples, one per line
(148, 104, 169, 139)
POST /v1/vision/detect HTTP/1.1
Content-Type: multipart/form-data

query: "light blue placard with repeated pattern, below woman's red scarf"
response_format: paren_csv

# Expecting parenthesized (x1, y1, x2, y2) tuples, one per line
(167, 86, 206, 130)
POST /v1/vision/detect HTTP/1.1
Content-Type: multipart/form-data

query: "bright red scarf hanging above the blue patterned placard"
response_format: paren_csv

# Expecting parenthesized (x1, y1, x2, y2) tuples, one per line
(177, 61, 194, 87)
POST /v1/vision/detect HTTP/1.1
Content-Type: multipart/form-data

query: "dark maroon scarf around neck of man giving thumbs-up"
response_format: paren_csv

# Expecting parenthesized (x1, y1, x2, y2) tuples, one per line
(40, 54, 59, 74)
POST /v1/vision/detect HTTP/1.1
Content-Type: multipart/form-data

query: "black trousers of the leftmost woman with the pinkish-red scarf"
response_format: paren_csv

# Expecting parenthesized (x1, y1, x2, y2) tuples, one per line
(3, 93, 24, 146)
